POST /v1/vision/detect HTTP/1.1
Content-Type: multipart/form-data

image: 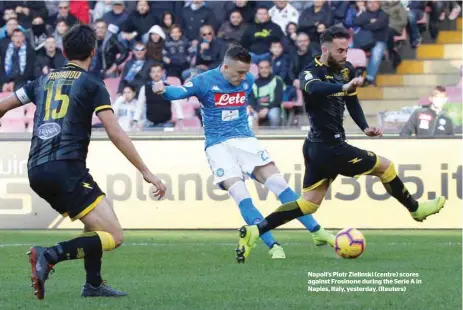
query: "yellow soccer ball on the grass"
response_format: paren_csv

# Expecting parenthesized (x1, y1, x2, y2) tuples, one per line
(334, 228, 367, 258)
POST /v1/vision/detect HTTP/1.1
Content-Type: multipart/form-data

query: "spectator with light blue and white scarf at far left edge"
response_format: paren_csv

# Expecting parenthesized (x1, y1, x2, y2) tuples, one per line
(0, 29, 35, 92)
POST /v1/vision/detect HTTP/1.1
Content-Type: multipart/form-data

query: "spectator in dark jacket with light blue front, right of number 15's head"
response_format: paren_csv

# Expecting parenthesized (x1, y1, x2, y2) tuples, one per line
(117, 42, 154, 94)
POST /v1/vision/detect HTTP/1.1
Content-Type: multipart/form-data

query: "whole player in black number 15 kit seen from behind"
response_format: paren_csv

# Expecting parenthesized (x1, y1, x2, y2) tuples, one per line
(0, 25, 166, 299)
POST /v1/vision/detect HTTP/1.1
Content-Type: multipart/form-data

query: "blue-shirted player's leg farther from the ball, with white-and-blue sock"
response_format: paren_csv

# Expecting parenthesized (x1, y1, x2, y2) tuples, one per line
(222, 178, 286, 259)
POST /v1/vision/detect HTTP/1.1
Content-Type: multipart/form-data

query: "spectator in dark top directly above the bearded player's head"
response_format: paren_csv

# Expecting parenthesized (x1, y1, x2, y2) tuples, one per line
(298, 0, 333, 41)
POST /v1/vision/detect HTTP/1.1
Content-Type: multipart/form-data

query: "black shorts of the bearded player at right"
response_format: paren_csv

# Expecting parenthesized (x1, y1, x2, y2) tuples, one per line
(303, 139, 379, 192)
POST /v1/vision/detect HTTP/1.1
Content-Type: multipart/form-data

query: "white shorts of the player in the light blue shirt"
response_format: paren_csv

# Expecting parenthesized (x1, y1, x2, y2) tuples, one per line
(206, 138, 272, 184)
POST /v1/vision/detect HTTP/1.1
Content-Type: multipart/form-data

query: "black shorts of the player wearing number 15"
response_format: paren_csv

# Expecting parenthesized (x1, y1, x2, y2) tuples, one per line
(29, 160, 105, 221)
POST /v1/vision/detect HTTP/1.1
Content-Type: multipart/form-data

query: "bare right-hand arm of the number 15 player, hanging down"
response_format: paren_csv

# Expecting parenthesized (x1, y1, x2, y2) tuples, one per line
(98, 110, 166, 199)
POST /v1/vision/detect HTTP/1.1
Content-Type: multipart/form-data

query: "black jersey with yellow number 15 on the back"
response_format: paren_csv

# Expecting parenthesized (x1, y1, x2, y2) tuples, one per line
(16, 62, 112, 169)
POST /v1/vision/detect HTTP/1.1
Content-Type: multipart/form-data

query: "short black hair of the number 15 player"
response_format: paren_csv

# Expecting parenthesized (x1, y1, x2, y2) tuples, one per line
(63, 25, 96, 61)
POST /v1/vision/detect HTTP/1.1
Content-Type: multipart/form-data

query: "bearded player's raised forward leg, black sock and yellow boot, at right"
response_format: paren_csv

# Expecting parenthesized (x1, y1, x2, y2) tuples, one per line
(371, 157, 445, 222)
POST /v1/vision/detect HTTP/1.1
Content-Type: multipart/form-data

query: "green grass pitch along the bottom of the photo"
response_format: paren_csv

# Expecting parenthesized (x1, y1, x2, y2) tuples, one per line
(0, 230, 462, 310)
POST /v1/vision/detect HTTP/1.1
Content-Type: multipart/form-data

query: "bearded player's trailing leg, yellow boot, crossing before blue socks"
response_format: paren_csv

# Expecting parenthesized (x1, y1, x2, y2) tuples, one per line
(236, 181, 329, 263)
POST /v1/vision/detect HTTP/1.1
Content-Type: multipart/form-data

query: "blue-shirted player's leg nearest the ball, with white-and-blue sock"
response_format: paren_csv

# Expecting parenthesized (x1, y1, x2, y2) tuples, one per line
(252, 162, 334, 246)
